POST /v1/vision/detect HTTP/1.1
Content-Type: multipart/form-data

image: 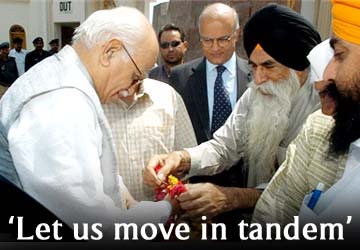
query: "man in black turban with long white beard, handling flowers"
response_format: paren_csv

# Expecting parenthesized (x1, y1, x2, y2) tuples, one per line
(144, 4, 321, 227)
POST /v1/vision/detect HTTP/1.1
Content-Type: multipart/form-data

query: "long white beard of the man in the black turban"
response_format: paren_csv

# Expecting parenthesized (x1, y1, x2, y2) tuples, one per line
(245, 70, 300, 186)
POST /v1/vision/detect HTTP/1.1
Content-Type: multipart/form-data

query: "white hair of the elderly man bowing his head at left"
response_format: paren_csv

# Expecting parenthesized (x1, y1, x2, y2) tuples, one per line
(72, 7, 146, 54)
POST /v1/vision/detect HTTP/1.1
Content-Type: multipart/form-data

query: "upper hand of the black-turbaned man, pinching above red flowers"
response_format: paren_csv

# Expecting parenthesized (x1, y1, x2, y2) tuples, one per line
(144, 150, 190, 188)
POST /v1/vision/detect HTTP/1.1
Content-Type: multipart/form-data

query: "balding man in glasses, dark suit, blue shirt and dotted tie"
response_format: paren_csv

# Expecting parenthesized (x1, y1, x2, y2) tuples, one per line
(170, 3, 250, 186)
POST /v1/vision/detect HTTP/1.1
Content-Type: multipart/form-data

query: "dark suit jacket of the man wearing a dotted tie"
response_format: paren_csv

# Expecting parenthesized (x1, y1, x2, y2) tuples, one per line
(170, 57, 250, 144)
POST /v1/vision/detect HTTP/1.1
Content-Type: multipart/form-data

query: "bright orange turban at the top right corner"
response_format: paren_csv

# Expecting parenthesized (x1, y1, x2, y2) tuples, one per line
(332, 0, 360, 45)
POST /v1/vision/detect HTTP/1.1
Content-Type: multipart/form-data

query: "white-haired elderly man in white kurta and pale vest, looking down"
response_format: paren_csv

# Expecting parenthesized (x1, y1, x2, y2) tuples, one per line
(0, 7, 176, 232)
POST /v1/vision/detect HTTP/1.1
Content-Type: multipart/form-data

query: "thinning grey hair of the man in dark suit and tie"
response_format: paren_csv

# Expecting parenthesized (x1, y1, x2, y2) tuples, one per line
(198, 3, 240, 32)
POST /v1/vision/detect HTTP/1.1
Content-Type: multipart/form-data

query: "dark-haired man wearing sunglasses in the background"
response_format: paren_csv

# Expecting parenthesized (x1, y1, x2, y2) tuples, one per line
(149, 23, 188, 83)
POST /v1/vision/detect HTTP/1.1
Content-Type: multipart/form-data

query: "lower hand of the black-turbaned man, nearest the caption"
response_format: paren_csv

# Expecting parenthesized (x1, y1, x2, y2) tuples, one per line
(178, 183, 229, 221)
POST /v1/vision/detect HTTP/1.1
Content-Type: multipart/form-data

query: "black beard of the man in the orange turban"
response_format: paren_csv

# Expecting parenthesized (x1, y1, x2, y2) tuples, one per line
(327, 79, 360, 157)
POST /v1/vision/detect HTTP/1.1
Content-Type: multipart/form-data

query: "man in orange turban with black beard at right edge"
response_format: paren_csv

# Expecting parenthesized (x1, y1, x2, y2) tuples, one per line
(253, 0, 360, 238)
